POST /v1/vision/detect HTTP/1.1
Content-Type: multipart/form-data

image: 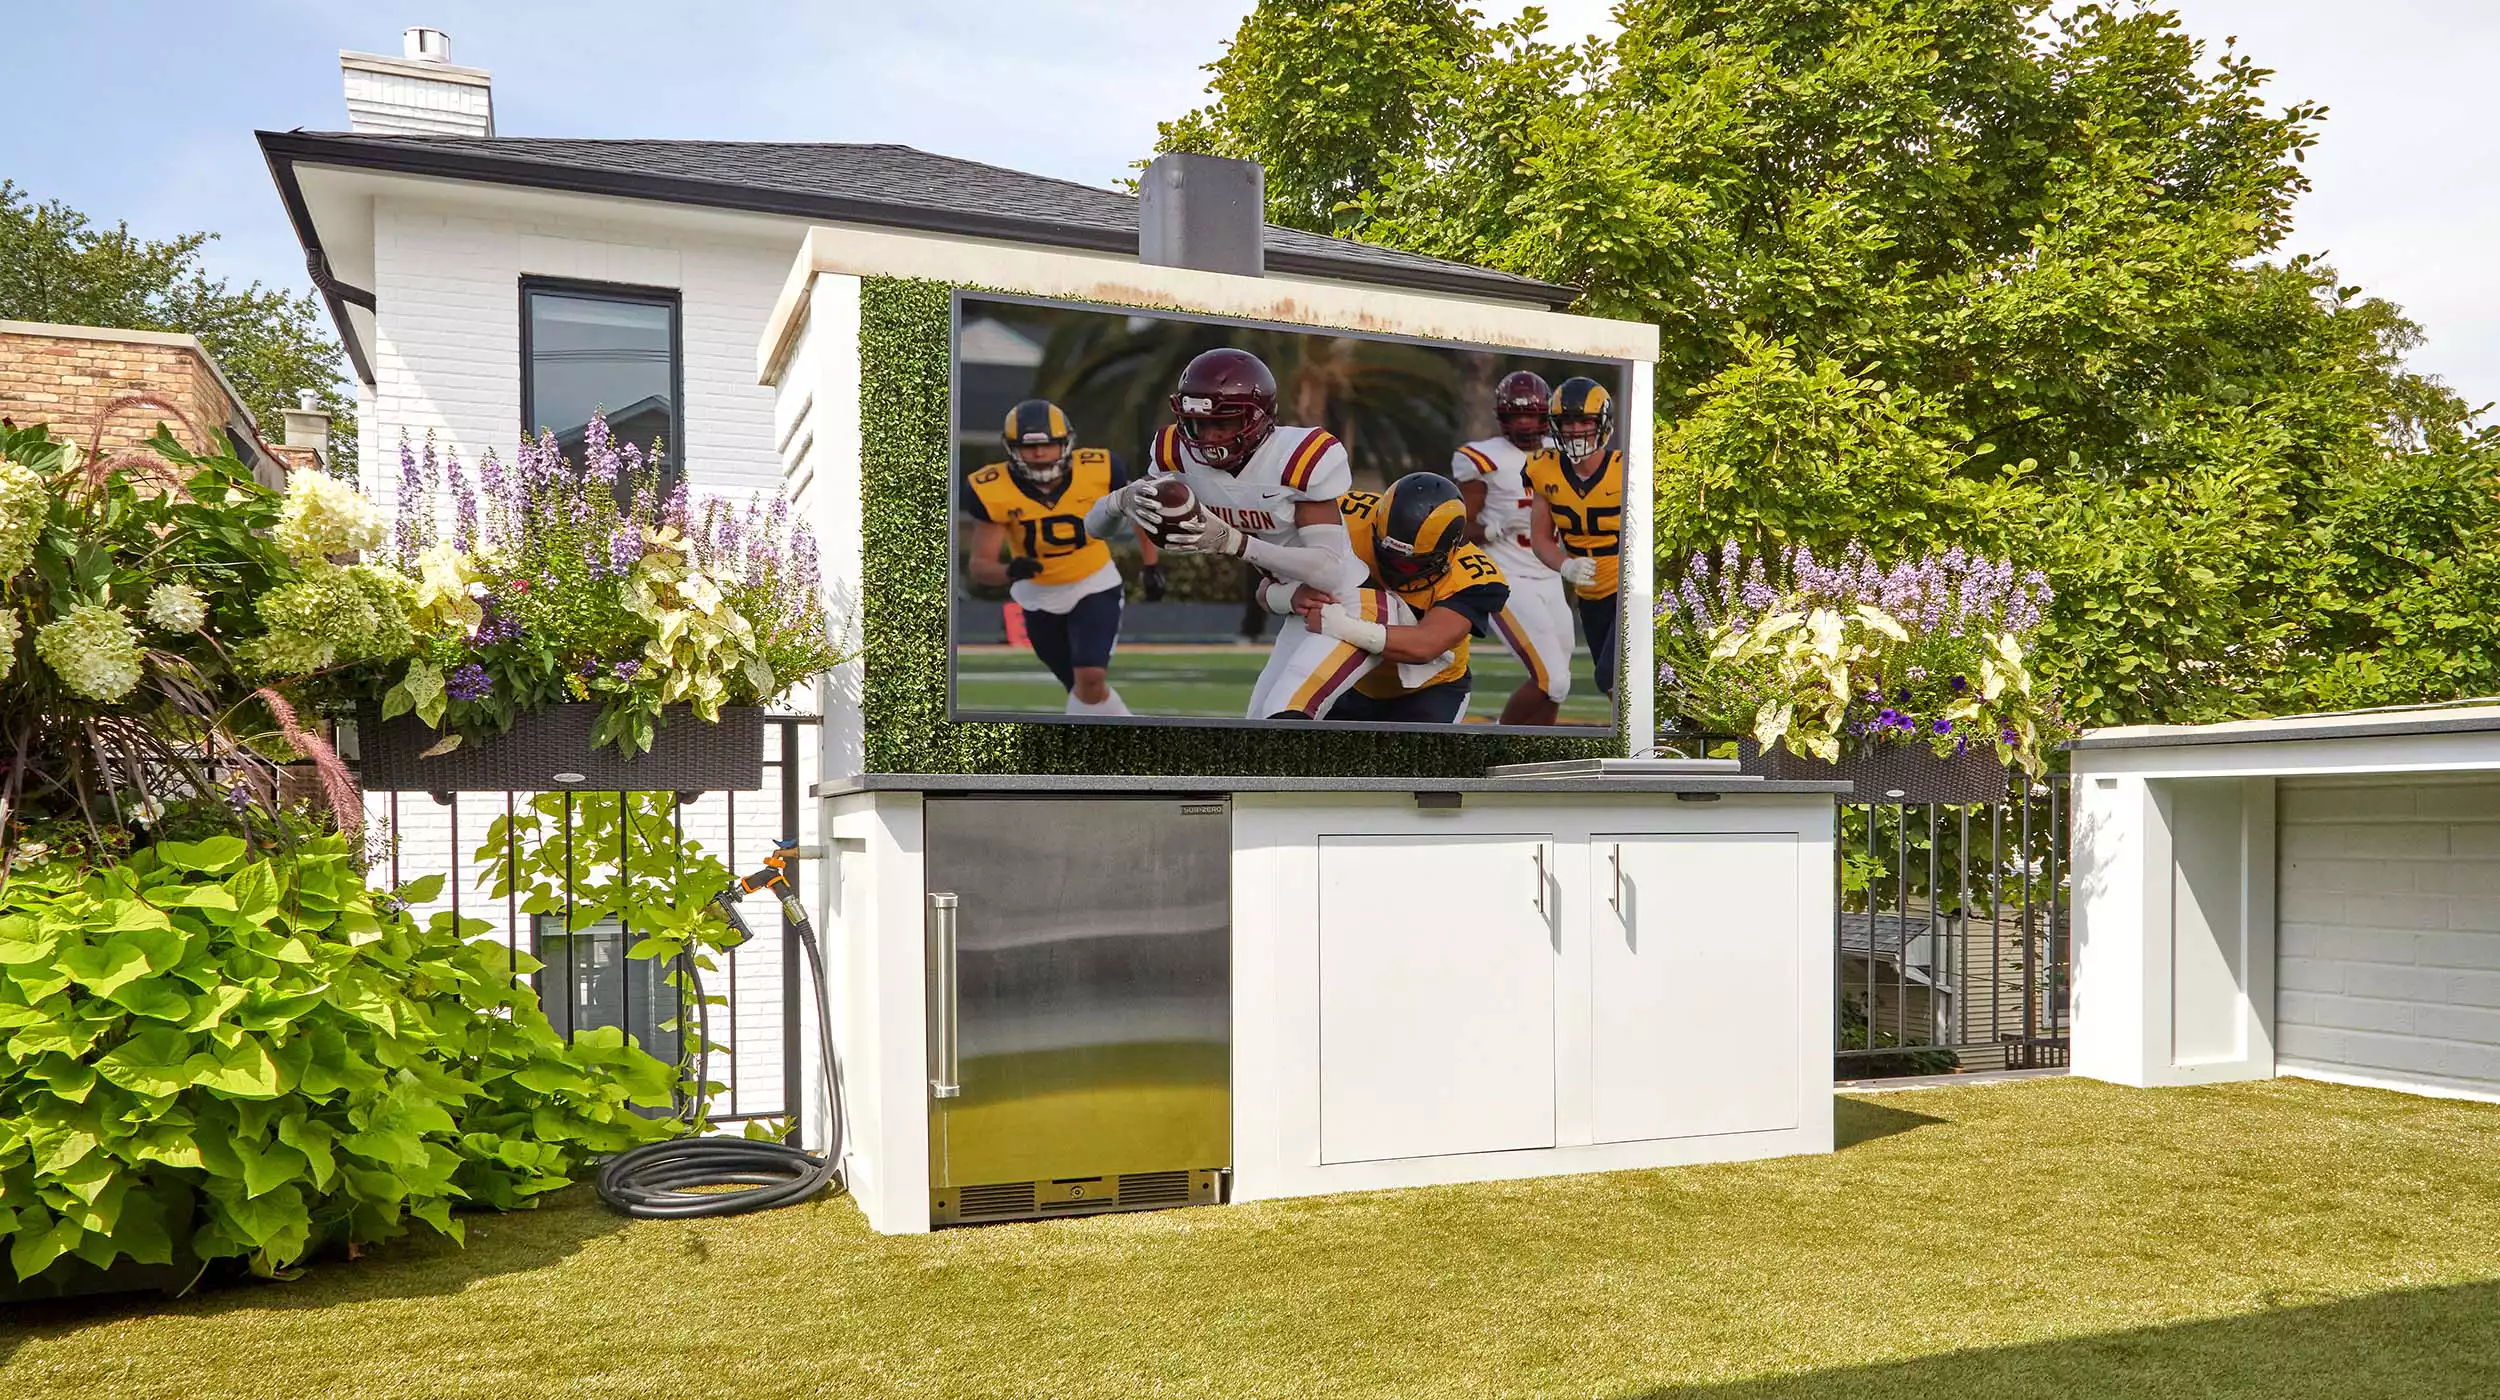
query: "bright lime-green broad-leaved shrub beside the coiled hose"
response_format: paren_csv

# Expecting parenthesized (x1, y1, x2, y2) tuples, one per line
(0, 830, 675, 1280)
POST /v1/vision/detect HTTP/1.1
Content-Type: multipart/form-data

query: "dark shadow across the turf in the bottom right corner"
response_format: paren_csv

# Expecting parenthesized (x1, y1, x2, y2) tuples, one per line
(1620, 1283, 2500, 1400)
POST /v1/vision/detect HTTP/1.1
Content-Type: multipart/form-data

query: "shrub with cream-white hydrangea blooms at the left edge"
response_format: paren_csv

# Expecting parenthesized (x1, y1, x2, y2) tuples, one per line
(0, 415, 365, 860)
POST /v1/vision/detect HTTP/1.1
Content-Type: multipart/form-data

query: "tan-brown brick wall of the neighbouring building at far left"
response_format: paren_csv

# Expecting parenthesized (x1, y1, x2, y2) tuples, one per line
(0, 323, 245, 465)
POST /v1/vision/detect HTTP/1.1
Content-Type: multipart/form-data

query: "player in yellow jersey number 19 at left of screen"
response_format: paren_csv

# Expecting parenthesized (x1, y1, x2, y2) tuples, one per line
(958, 398, 1163, 715)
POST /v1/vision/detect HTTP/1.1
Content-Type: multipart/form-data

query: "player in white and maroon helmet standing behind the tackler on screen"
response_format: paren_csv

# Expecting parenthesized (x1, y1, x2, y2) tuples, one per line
(1450, 370, 1573, 725)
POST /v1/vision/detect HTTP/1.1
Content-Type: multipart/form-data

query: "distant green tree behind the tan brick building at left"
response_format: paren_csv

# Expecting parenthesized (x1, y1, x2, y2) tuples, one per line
(0, 180, 355, 470)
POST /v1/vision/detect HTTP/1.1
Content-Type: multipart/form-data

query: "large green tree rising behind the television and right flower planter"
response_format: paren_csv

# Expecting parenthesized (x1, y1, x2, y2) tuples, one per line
(1163, 0, 2500, 723)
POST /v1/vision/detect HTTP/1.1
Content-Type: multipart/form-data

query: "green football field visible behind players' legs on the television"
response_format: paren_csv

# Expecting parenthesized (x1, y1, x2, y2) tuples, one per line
(955, 645, 1608, 725)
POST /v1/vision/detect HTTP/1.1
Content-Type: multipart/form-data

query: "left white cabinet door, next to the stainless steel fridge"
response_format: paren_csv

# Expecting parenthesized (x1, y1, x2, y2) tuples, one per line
(1320, 835, 1558, 1163)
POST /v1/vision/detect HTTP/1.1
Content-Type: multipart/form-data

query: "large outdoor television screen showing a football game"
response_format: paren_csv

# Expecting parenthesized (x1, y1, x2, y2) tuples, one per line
(950, 293, 1628, 733)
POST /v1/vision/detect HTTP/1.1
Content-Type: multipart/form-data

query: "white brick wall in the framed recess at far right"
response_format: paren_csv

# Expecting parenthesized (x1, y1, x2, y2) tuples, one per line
(2275, 778, 2500, 1098)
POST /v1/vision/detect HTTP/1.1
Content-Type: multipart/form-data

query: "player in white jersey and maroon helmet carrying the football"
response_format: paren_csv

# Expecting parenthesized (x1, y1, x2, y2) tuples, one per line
(1085, 348, 1368, 720)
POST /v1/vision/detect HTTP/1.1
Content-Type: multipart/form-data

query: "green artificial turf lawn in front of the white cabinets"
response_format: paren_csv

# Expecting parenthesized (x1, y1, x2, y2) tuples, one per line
(0, 1068, 2500, 1400)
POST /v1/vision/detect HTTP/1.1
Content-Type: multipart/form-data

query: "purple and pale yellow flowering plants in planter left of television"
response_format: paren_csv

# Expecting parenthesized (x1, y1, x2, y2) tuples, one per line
(383, 415, 843, 755)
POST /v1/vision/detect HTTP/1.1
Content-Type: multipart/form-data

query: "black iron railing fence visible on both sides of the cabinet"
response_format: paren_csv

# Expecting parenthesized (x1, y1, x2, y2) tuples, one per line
(368, 715, 2070, 1123)
